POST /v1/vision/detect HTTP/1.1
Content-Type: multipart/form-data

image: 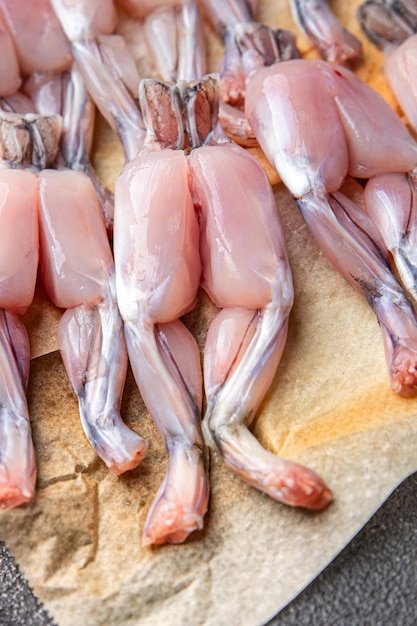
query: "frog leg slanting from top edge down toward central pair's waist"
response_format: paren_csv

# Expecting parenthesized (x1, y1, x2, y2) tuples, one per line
(51, 0, 145, 161)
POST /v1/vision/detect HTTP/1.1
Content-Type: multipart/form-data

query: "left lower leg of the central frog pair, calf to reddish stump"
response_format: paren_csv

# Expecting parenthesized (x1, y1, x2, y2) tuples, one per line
(125, 320, 209, 545)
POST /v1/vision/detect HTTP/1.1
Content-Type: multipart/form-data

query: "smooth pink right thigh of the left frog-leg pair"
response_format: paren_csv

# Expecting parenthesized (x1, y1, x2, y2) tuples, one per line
(39, 170, 113, 309)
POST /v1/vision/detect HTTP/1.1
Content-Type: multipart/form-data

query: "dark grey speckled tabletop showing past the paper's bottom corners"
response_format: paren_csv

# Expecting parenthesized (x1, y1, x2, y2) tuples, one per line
(0, 473, 417, 626)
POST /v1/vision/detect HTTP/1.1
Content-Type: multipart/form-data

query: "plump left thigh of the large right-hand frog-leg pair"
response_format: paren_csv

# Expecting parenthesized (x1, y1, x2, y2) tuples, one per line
(245, 59, 349, 198)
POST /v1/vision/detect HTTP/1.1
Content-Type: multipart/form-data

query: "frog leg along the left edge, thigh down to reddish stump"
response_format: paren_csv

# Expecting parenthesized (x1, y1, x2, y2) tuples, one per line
(0, 169, 39, 509)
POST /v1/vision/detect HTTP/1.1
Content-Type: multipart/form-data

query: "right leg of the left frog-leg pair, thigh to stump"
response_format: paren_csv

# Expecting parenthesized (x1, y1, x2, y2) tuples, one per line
(38, 170, 147, 474)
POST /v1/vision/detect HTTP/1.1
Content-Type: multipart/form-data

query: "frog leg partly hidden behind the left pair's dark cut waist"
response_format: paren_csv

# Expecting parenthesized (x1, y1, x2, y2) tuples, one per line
(25, 63, 113, 233)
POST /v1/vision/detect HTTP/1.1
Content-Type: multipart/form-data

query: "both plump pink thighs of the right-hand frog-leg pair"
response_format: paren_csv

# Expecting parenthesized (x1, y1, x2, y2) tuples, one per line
(245, 59, 417, 190)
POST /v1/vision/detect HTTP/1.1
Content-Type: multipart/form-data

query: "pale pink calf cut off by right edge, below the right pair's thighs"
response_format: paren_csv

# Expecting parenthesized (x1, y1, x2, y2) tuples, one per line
(364, 173, 417, 299)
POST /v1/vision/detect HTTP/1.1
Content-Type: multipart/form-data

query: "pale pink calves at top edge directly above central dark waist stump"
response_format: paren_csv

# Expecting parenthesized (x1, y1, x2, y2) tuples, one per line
(144, 1, 207, 82)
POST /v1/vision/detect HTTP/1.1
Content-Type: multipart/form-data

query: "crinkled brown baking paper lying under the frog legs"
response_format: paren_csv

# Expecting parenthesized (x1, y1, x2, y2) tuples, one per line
(0, 0, 417, 626)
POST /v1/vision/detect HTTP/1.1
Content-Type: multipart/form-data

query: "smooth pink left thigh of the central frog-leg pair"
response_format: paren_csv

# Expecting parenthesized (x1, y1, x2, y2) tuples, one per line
(114, 150, 200, 322)
